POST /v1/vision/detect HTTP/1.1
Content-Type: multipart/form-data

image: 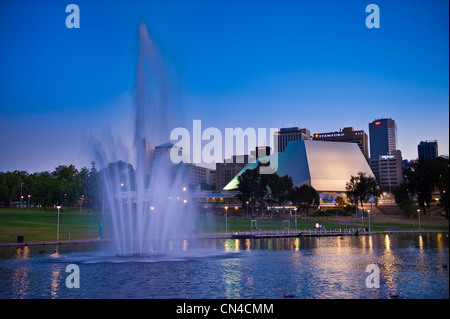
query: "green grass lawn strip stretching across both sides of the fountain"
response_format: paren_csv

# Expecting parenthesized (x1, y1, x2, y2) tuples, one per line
(0, 208, 448, 243)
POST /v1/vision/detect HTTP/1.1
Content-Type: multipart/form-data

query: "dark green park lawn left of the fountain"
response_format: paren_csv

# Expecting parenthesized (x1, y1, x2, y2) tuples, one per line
(0, 208, 100, 243)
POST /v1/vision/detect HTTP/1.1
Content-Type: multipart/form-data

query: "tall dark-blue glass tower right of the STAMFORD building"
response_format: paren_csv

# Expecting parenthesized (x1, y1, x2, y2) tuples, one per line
(369, 118, 397, 157)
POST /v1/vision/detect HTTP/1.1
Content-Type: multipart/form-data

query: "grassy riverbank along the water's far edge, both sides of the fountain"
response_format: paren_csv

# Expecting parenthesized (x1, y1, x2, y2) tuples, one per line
(0, 209, 448, 246)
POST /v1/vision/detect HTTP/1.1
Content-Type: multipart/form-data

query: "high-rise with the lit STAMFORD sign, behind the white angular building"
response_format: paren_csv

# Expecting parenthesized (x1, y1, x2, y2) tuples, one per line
(313, 127, 369, 161)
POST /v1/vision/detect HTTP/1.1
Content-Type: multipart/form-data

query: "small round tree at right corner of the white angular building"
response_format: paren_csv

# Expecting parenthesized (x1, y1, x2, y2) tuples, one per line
(345, 172, 381, 214)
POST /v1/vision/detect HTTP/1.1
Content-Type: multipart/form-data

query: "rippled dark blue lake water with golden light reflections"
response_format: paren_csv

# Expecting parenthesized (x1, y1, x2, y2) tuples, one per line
(0, 233, 449, 299)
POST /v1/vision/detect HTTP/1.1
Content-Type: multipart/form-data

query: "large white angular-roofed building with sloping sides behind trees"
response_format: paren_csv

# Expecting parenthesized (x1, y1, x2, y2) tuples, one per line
(223, 140, 375, 204)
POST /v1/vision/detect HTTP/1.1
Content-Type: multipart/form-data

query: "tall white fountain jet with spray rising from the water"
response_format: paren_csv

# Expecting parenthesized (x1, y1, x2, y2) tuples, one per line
(94, 23, 196, 256)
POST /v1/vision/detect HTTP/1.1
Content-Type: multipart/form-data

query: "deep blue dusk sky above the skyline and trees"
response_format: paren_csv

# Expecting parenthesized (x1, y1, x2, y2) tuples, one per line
(0, 0, 449, 172)
